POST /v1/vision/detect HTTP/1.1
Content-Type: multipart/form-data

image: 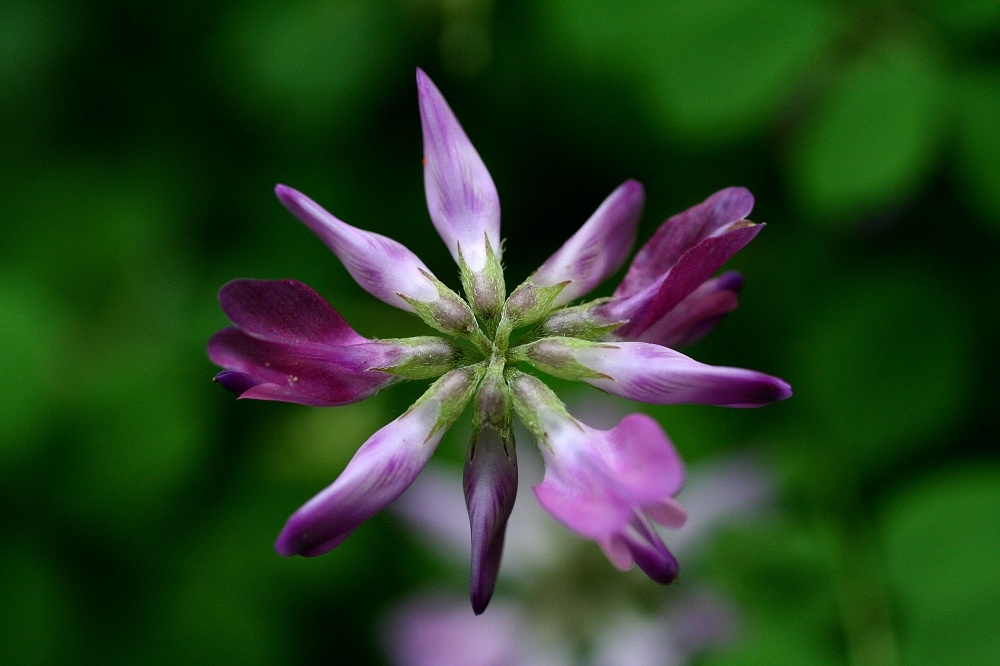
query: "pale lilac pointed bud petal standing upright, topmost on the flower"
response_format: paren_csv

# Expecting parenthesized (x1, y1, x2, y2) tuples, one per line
(417, 69, 500, 273)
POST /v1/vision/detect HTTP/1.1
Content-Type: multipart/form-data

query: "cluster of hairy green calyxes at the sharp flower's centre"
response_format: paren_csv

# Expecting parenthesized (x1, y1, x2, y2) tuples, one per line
(396, 242, 624, 442)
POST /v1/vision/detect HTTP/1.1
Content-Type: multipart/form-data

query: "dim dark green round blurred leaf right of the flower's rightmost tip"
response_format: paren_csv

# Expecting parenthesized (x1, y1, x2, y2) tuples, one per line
(791, 267, 971, 474)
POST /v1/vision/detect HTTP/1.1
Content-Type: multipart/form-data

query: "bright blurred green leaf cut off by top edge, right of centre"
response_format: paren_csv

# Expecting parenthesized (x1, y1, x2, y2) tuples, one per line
(643, 0, 836, 145)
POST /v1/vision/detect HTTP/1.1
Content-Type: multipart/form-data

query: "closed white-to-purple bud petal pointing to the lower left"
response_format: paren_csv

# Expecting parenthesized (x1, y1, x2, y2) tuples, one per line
(275, 400, 445, 557)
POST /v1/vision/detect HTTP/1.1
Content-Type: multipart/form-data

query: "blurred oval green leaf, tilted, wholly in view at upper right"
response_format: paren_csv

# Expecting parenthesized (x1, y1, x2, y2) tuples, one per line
(789, 41, 943, 225)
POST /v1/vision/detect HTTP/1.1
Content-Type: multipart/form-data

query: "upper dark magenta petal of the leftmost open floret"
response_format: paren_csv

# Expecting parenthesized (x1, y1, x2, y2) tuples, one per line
(219, 280, 368, 345)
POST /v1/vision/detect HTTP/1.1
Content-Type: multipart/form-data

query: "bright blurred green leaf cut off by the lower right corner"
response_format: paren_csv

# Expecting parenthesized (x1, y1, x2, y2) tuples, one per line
(882, 465, 1000, 665)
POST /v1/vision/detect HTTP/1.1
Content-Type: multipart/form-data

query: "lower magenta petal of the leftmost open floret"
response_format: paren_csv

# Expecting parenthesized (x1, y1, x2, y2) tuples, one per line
(208, 328, 399, 407)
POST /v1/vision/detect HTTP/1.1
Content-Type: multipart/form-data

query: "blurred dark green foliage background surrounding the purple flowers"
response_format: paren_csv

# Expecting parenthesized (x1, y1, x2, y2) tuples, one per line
(0, 0, 1000, 665)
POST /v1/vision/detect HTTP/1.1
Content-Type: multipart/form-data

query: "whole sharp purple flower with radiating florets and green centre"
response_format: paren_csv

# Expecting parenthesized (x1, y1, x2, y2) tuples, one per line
(208, 70, 790, 613)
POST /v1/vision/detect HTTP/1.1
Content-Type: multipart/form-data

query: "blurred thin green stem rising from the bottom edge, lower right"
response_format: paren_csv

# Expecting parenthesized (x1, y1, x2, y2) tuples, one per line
(832, 482, 900, 666)
